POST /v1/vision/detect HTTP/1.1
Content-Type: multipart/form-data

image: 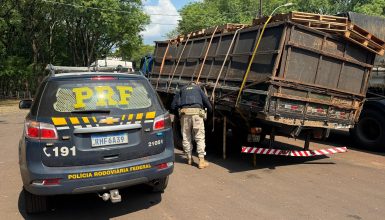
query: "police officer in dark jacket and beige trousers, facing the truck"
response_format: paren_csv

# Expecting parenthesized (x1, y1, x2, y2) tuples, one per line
(171, 82, 212, 169)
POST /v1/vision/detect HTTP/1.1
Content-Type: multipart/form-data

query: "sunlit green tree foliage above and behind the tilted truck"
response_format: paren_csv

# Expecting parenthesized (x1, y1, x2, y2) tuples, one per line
(173, 0, 385, 34)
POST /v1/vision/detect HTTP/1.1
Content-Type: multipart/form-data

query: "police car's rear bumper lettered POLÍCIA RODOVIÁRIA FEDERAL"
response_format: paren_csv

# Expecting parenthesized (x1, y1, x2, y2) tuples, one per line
(20, 148, 174, 195)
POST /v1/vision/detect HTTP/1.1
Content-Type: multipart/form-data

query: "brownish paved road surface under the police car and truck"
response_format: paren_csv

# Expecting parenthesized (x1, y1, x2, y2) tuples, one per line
(0, 105, 385, 220)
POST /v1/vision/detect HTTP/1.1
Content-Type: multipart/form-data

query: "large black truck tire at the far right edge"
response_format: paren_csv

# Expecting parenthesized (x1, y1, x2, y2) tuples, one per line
(351, 109, 385, 151)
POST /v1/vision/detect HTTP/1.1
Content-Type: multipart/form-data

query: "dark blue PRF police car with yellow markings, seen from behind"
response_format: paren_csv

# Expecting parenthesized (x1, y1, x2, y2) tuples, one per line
(19, 66, 174, 213)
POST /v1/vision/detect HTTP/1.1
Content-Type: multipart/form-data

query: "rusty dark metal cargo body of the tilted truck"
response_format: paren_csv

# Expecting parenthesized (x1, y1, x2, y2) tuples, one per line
(149, 21, 375, 150)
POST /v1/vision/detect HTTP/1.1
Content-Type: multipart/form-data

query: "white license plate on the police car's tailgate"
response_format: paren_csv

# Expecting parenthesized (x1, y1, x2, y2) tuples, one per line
(91, 132, 128, 147)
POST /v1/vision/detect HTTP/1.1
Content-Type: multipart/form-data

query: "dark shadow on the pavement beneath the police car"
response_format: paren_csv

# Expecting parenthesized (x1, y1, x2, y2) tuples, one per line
(18, 185, 162, 219)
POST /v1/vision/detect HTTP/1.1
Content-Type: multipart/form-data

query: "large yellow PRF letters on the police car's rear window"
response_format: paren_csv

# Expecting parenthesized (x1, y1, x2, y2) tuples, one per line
(72, 86, 132, 109)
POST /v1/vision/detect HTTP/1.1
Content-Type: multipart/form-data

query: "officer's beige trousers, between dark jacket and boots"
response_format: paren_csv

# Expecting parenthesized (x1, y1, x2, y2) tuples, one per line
(181, 115, 206, 158)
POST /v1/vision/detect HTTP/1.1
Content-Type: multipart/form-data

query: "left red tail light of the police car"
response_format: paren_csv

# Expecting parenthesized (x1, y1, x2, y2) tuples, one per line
(25, 121, 58, 140)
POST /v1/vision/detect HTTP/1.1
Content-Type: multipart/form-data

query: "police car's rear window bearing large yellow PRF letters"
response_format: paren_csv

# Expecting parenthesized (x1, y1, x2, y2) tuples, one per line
(39, 80, 159, 116)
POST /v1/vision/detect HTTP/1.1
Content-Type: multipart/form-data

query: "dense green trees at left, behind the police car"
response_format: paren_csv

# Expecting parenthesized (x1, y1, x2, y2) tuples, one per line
(0, 0, 149, 96)
